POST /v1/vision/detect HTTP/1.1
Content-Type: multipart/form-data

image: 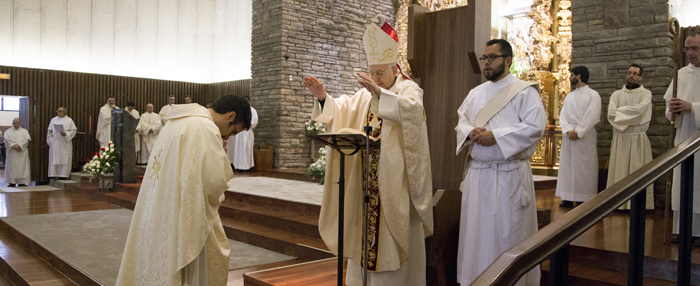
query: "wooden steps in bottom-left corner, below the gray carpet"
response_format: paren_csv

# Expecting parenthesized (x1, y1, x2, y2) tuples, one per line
(0, 220, 89, 285)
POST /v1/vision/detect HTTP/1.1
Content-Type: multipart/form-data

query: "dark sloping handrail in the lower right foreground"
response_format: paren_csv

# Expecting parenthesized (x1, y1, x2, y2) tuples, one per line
(471, 132, 700, 285)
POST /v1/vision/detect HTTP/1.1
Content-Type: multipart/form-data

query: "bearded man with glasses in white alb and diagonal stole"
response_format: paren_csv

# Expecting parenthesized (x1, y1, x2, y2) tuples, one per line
(455, 39, 547, 285)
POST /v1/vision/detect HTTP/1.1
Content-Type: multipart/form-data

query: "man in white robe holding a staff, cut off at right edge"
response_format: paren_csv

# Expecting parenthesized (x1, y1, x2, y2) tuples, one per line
(664, 32, 700, 246)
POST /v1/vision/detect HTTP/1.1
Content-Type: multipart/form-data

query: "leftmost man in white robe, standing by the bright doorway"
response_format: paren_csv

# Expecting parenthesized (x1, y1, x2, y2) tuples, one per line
(5, 118, 32, 186)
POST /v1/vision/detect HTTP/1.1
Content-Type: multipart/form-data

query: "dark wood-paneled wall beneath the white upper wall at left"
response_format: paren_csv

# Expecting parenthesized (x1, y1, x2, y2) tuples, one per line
(0, 66, 250, 182)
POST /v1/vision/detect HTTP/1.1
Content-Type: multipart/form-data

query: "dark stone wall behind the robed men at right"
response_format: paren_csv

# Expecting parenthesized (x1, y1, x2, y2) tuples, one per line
(571, 0, 673, 206)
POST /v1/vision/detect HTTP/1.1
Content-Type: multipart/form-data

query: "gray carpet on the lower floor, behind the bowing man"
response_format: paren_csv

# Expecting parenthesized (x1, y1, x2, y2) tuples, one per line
(2, 209, 294, 285)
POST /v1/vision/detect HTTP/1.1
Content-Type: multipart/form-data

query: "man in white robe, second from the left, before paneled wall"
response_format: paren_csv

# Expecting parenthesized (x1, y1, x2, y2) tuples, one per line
(46, 107, 78, 179)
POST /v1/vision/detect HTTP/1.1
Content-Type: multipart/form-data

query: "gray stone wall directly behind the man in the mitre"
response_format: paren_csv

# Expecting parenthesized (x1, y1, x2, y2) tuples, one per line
(251, 0, 396, 169)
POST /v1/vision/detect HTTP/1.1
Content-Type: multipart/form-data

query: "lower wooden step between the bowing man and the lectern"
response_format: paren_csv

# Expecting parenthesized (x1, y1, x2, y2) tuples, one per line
(221, 217, 333, 261)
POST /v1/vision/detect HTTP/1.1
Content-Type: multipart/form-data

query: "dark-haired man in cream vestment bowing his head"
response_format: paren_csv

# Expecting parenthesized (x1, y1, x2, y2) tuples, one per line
(117, 95, 250, 286)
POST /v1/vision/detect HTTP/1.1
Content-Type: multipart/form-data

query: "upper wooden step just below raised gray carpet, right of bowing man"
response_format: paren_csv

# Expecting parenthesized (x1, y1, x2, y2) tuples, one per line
(219, 201, 321, 239)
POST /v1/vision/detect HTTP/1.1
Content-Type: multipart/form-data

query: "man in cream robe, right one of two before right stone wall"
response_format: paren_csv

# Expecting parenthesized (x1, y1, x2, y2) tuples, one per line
(607, 64, 654, 210)
